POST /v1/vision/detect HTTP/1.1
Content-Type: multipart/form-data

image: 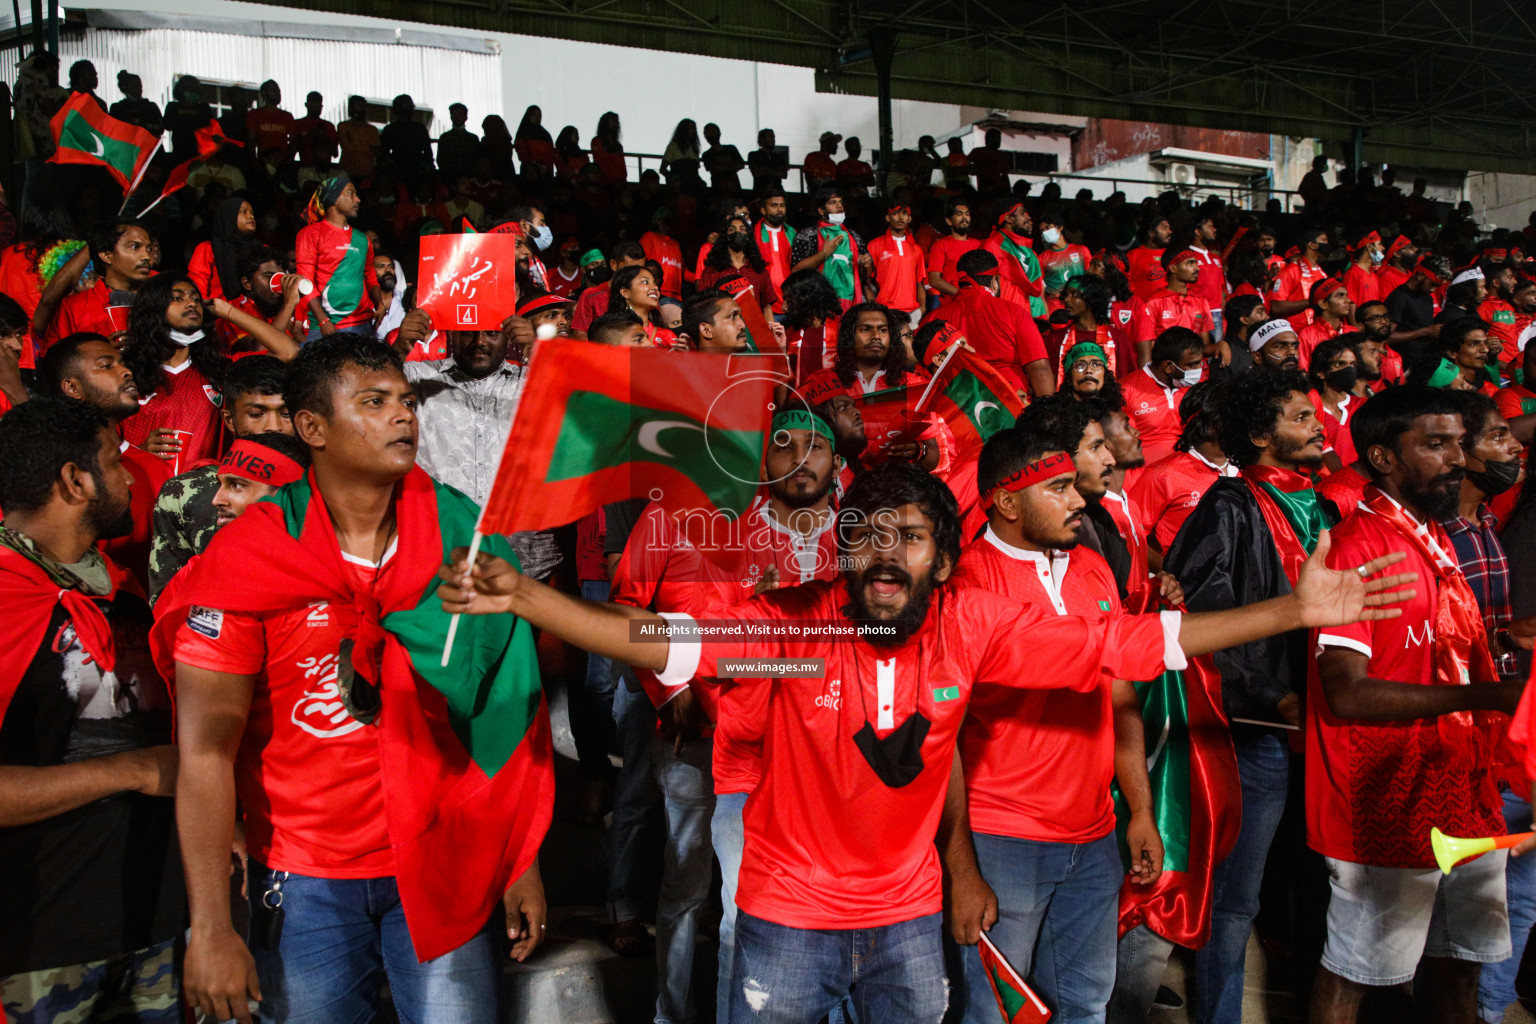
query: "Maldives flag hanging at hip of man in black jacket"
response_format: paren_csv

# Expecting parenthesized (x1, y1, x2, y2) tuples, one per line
(1112, 656, 1243, 949)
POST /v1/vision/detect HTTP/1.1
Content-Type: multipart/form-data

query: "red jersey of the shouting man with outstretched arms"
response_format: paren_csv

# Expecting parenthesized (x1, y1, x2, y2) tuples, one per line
(662, 580, 1184, 929)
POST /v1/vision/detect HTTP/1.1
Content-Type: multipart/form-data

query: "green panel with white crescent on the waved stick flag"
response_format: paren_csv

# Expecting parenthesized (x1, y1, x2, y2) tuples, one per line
(545, 391, 763, 514)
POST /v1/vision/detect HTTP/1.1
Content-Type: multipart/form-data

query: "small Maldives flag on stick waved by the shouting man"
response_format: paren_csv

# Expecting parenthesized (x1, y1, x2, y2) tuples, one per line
(482, 341, 786, 543)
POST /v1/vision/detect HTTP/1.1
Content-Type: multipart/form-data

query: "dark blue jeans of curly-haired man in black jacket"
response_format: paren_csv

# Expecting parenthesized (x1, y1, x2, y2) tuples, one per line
(1193, 726, 1290, 1024)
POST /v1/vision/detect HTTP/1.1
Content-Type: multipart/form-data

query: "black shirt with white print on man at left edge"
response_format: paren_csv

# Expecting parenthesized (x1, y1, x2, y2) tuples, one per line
(0, 591, 187, 975)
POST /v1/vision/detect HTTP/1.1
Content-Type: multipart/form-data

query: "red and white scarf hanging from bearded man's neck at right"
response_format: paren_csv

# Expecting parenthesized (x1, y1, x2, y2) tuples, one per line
(1356, 485, 1499, 760)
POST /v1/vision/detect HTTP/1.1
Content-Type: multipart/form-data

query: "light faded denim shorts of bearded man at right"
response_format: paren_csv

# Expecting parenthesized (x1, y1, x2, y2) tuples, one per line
(1322, 851, 1510, 986)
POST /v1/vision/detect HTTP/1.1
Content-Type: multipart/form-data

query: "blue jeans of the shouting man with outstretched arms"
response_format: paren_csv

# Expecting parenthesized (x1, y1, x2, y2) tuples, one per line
(731, 912, 949, 1024)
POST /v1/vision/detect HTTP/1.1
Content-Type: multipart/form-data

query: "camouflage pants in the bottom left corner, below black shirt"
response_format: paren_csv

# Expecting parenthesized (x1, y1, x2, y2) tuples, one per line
(0, 940, 183, 1024)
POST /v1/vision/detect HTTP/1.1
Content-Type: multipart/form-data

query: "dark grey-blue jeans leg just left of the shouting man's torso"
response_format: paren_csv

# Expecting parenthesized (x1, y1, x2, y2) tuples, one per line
(651, 735, 714, 1024)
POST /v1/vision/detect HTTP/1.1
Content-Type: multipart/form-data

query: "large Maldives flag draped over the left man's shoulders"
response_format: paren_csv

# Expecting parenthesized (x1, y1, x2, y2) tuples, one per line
(151, 468, 554, 961)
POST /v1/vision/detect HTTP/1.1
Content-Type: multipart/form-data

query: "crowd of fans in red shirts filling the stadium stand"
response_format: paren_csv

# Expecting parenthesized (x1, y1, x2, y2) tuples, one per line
(0, 54, 1536, 1024)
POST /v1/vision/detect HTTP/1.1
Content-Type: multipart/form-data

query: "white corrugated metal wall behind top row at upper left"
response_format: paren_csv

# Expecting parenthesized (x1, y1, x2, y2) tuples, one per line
(60, 21, 500, 137)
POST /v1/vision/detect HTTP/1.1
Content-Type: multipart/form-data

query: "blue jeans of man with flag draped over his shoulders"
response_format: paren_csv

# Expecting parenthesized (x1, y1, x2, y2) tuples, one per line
(250, 860, 501, 1024)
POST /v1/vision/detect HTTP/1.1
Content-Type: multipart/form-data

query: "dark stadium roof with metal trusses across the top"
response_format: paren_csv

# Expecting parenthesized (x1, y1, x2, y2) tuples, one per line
(251, 0, 1536, 173)
